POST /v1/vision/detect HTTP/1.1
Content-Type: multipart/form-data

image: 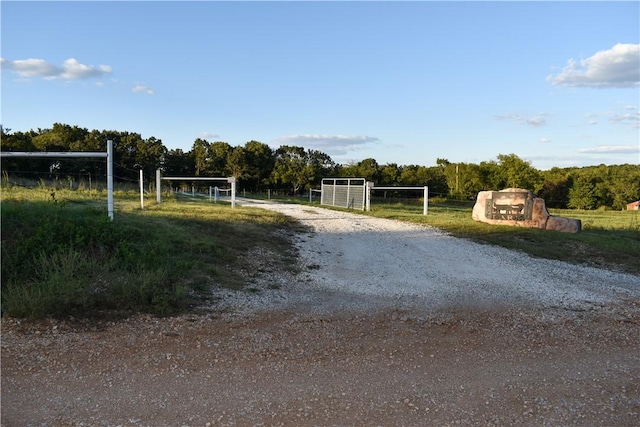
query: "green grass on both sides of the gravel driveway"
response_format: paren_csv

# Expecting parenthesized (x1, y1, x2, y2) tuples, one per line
(1, 185, 640, 318)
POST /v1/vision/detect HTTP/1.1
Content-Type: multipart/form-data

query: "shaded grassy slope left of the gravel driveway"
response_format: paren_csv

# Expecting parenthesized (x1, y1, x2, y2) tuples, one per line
(1, 189, 298, 318)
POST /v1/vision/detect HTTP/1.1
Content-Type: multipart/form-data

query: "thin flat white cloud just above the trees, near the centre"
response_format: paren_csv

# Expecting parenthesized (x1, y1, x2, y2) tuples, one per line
(273, 134, 380, 156)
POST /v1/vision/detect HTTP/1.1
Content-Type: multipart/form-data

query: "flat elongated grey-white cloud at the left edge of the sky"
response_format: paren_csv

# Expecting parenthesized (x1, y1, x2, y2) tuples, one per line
(0, 58, 112, 80)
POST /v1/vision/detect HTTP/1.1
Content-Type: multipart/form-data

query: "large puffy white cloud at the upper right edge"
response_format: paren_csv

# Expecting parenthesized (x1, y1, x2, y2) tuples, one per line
(547, 43, 640, 88)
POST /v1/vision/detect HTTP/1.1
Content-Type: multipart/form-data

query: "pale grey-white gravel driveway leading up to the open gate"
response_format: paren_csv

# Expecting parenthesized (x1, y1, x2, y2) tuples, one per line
(216, 199, 640, 310)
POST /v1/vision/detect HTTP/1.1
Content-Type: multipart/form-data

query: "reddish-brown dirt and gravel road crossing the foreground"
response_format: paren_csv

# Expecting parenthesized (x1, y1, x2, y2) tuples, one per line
(2, 301, 640, 426)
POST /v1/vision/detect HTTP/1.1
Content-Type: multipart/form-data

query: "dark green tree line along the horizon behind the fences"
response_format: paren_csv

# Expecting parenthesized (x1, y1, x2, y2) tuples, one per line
(0, 123, 640, 209)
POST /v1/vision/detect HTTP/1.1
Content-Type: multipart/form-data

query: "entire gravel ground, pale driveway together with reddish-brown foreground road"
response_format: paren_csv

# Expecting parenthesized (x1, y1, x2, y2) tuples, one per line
(1, 200, 640, 426)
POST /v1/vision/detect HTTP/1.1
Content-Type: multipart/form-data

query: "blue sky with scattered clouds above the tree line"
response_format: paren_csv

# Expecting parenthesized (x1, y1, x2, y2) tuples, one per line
(0, 1, 640, 170)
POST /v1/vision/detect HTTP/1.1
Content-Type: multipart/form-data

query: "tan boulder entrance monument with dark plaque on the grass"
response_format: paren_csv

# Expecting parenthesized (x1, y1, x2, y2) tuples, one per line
(471, 188, 582, 233)
